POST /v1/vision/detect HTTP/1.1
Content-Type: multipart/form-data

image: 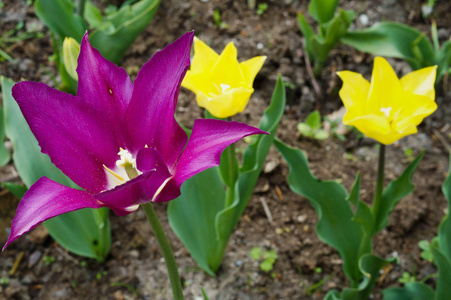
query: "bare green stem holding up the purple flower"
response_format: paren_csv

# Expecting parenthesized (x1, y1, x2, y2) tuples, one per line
(141, 203, 184, 300)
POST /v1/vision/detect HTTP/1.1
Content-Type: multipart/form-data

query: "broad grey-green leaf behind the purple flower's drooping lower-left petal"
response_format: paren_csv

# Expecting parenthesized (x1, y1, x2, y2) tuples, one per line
(0, 77, 111, 260)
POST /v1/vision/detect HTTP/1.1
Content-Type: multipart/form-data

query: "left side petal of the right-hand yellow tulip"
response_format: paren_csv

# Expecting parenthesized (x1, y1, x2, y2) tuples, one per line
(337, 71, 370, 119)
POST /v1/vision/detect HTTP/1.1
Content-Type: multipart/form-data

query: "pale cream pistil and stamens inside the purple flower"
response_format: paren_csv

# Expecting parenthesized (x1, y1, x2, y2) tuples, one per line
(103, 148, 142, 188)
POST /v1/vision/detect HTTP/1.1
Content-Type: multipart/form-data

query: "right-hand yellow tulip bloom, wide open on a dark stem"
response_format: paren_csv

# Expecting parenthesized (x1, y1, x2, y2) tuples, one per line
(337, 57, 437, 145)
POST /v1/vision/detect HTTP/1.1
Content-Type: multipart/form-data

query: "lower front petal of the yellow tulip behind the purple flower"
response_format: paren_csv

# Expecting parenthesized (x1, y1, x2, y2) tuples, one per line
(196, 87, 254, 118)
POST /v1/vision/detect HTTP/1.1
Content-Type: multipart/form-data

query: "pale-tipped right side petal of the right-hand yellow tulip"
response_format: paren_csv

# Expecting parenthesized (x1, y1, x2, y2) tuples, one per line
(401, 66, 437, 100)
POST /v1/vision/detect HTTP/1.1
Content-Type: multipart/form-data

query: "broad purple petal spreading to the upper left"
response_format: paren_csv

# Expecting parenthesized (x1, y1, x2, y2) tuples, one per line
(12, 82, 120, 193)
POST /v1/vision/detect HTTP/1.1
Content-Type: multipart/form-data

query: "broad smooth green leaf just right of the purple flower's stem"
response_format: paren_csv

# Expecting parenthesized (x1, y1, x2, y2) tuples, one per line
(168, 167, 226, 276)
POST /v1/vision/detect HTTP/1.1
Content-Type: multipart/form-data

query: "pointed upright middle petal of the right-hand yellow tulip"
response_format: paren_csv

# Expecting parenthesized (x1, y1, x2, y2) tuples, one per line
(367, 57, 404, 116)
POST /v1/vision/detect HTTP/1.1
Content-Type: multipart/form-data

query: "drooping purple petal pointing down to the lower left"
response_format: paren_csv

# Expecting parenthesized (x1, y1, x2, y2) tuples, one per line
(3, 177, 103, 250)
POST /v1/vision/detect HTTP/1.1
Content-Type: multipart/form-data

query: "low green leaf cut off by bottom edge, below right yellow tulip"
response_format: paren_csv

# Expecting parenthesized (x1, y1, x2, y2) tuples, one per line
(382, 282, 436, 300)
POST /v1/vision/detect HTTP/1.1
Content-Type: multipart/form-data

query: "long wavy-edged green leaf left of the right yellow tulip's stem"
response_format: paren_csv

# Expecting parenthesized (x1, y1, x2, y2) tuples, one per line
(274, 139, 364, 282)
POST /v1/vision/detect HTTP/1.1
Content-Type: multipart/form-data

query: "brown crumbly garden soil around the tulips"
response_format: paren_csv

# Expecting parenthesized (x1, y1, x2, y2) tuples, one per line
(0, 0, 451, 299)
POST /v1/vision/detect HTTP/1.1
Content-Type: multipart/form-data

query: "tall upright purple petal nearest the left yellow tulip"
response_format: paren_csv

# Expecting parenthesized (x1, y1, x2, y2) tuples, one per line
(127, 32, 194, 166)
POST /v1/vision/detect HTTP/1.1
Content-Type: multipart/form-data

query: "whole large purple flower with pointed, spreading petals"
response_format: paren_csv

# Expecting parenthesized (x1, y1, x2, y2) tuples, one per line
(3, 32, 265, 249)
